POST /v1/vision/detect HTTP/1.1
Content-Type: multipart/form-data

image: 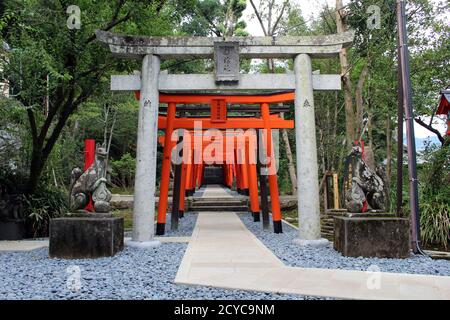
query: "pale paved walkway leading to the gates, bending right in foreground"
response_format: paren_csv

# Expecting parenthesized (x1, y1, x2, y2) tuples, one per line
(175, 212, 450, 299)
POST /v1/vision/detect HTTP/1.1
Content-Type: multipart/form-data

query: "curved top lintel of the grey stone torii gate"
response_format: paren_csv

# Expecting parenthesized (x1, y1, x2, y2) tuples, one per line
(95, 30, 355, 59)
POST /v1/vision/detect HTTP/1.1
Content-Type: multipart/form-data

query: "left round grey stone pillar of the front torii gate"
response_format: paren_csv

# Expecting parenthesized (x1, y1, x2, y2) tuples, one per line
(127, 55, 160, 248)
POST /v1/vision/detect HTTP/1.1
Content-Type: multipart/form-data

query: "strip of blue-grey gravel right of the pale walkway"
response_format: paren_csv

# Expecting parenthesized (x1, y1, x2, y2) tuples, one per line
(239, 214, 450, 276)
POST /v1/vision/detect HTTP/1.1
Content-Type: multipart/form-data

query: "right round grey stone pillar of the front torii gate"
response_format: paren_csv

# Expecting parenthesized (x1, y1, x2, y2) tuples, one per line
(294, 54, 328, 246)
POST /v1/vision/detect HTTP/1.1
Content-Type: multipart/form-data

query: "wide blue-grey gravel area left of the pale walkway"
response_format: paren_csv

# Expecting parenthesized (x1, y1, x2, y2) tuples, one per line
(0, 243, 310, 300)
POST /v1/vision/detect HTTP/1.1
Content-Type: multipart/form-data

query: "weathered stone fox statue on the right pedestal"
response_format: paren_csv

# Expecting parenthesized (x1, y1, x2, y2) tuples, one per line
(345, 146, 386, 213)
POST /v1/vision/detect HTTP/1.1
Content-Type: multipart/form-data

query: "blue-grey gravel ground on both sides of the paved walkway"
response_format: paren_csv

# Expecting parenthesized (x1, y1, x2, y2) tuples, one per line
(0, 210, 450, 300)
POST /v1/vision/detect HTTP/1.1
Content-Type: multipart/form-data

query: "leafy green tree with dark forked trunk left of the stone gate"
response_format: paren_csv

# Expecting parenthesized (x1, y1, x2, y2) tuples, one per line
(0, 0, 178, 193)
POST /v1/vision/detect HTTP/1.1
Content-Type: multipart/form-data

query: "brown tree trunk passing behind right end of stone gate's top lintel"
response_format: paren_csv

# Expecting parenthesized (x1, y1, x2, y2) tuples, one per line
(336, 0, 356, 151)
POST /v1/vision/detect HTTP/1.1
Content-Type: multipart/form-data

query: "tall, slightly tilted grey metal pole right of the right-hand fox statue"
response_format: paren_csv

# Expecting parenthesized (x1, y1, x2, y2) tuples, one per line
(397, 0, 420, 253)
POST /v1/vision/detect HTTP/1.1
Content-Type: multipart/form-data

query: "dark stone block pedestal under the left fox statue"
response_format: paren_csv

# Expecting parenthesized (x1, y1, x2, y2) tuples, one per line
(49, 214, 124, 259)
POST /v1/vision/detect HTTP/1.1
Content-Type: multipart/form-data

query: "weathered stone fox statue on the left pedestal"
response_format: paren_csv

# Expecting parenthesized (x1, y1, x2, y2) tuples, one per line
(69, 146, 111, 213)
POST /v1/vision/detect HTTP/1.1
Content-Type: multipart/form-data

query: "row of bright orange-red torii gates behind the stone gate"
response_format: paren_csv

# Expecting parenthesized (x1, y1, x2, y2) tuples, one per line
(156, 92, 294, 235)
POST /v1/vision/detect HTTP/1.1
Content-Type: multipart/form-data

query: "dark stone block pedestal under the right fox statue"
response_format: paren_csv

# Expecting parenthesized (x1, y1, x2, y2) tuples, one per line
(334, 217, 410, 258)
